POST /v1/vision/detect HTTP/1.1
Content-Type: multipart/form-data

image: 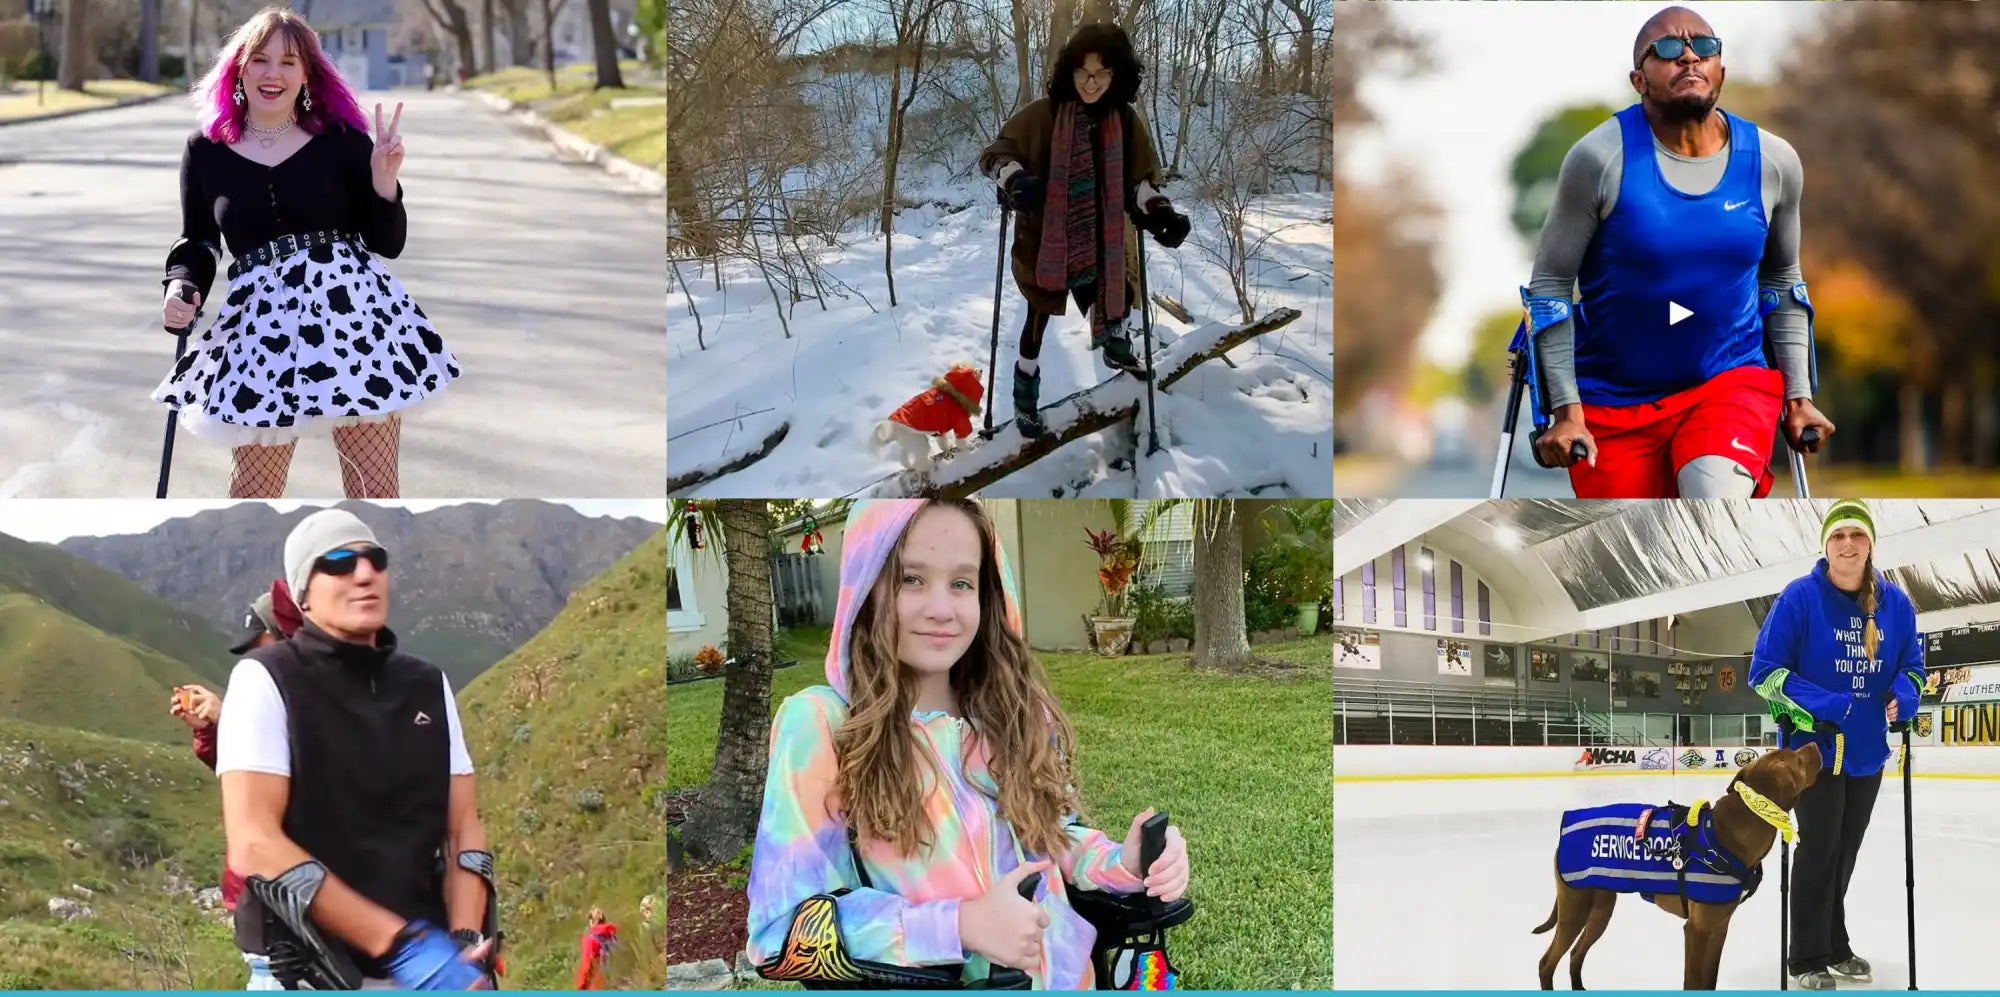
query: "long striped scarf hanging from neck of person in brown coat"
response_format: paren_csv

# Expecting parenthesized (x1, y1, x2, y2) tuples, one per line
(1034, 100, 1126, 322)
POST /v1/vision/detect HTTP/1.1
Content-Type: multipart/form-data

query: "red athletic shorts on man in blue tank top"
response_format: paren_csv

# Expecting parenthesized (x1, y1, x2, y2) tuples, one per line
(1570, 366, 1784, 499)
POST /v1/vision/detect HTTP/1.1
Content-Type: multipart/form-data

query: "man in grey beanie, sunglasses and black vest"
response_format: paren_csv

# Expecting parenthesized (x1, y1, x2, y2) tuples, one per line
(216, 509, 500, 989)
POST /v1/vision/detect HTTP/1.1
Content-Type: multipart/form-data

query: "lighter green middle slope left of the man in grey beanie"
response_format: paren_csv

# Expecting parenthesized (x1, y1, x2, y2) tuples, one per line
(0, 591, 220, 743)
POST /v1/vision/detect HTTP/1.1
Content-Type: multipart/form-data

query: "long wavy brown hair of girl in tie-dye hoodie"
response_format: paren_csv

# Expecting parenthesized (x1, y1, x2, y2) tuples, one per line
(834, 501, 1078, 855)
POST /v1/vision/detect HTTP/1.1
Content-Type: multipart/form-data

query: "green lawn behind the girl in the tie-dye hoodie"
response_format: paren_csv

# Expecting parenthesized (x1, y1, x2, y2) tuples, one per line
(668, 631, 1334, 989)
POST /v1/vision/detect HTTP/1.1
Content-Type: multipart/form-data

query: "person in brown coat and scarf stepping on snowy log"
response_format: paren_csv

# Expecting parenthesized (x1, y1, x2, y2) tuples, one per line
(980, 24, 1190, 436)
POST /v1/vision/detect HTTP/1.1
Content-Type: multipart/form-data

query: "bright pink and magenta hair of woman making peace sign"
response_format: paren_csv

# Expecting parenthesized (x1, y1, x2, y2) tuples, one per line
(190, 6, 368, 144)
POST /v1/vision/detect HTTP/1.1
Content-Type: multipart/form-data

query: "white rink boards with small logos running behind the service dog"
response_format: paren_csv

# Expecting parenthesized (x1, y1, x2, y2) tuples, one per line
(1334, 735, 2000, 783)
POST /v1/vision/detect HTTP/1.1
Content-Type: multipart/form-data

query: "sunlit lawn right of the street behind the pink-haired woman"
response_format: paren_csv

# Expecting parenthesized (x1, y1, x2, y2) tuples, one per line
(466, 62, 666, 172)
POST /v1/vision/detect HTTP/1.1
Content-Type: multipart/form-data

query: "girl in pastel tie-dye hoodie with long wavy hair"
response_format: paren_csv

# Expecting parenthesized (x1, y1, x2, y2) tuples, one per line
(748, 501, 1188, 989)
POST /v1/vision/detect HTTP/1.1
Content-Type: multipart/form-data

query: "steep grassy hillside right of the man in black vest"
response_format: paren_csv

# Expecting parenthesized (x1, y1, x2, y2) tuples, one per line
(458, 531, 666, 989)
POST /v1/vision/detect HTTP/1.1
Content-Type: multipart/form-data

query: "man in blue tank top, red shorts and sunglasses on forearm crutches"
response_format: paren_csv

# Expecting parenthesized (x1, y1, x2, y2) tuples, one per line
(1522, 6, 1834, 499)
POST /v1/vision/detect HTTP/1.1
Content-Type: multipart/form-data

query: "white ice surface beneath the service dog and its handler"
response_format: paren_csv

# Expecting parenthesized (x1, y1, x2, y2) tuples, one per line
(1334, 768, 2000, 991)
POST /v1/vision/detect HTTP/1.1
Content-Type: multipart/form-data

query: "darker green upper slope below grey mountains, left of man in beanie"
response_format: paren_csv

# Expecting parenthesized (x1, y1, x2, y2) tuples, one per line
(0, 535, 234, 689)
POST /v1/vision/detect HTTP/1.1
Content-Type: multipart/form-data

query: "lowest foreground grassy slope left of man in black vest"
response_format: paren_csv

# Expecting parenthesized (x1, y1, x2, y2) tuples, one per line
(0, 716, 246, 989)
